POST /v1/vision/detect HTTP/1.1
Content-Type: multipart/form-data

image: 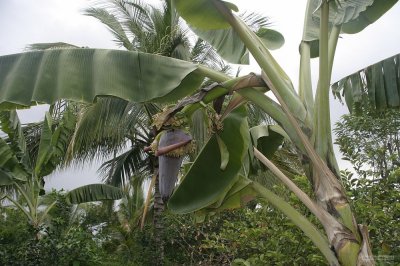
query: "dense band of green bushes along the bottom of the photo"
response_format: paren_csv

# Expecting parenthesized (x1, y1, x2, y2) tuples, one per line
(0, 170, 400, 265)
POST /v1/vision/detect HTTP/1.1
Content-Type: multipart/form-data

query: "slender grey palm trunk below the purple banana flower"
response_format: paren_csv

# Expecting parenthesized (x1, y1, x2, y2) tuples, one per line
(153, 171, 165, 266)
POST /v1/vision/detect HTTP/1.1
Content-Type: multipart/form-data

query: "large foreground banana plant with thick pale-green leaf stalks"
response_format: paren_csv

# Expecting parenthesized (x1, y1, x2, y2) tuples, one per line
(0, 0, 397, 265)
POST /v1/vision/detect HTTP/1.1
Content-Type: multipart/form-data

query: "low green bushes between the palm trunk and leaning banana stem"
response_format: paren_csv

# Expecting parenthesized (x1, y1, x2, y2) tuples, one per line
(161, 206, 325, 265)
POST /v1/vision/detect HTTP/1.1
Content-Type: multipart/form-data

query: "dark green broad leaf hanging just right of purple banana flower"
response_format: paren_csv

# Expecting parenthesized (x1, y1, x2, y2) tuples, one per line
(168, 107, 249, 213)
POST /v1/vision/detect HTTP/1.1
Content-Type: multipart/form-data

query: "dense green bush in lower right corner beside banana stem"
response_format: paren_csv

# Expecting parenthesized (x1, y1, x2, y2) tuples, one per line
(342, 169, 400, 265)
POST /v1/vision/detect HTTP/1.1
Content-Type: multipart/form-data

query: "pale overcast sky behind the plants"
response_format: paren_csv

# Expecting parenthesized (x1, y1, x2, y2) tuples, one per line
(0, 0, 400, 189)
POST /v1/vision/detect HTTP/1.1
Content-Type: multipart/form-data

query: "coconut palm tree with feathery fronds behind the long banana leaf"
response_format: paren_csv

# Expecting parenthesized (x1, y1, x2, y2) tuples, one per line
(50, 0, 238, 264)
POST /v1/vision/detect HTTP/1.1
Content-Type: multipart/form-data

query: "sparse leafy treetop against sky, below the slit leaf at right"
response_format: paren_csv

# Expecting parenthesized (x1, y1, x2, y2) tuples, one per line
(335, 106, 400, 178)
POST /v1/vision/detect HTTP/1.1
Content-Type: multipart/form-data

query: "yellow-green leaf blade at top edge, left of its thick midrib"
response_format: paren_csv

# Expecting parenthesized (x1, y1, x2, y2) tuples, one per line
(173, 0, 238, 30)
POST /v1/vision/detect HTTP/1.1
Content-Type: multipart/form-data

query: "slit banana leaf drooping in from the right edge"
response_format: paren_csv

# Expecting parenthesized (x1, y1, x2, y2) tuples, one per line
(332, 54, 400, 112)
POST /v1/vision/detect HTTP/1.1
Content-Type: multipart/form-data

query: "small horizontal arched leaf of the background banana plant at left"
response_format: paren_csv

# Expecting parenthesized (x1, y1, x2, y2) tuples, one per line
(66, 184, 124, 204)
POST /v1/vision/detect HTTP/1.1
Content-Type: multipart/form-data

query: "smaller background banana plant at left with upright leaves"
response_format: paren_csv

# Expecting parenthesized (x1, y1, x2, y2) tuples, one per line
(0, 110, 123, 233)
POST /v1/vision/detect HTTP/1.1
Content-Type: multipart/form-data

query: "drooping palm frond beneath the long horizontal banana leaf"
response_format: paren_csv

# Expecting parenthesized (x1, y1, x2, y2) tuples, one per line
(68, 98, 147, 162)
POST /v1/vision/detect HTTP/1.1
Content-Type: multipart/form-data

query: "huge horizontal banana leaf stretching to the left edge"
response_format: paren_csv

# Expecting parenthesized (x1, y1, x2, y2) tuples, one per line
(0, 49, 204, 108)
